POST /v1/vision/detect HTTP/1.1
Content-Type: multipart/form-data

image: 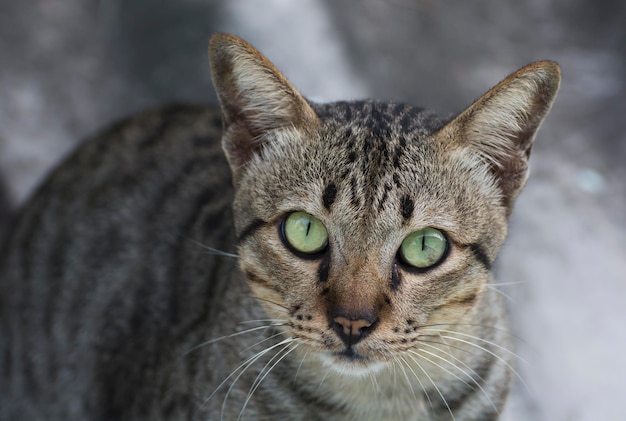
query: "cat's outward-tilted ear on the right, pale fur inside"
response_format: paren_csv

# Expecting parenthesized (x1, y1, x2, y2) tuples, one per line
(440, 61, 561, 211)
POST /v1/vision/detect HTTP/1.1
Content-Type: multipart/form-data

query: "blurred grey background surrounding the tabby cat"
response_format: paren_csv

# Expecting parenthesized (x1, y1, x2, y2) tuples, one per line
(0, 0, 626, 421)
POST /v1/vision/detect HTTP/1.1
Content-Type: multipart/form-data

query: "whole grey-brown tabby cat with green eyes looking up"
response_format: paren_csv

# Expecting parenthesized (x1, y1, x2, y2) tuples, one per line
(0, 34, 560, 420)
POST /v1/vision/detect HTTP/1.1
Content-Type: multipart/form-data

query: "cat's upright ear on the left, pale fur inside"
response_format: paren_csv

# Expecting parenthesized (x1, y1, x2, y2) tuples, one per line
(209, 34, 319, 178)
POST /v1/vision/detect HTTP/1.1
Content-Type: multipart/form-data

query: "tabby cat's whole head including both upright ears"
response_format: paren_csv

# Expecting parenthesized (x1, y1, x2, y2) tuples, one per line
(210, 35, 560, 372)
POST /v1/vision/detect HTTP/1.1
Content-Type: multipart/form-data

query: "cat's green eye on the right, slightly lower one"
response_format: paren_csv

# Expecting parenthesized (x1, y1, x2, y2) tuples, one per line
(400, 228, 448, 269)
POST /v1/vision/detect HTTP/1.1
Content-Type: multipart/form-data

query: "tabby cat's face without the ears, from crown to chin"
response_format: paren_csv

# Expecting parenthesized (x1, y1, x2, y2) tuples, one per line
(229, 102, 506, 369)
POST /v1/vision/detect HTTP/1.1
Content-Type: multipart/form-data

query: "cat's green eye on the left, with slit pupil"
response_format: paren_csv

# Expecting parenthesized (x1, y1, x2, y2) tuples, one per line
(282, 212, 328, 254)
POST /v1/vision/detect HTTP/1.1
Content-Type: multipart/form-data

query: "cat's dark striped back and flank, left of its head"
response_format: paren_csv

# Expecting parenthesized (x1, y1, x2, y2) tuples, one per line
(0, 106, 234, 419)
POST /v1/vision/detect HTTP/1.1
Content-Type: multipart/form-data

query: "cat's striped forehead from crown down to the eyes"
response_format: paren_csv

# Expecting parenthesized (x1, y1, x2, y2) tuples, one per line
(236, 101, 500, 243)
